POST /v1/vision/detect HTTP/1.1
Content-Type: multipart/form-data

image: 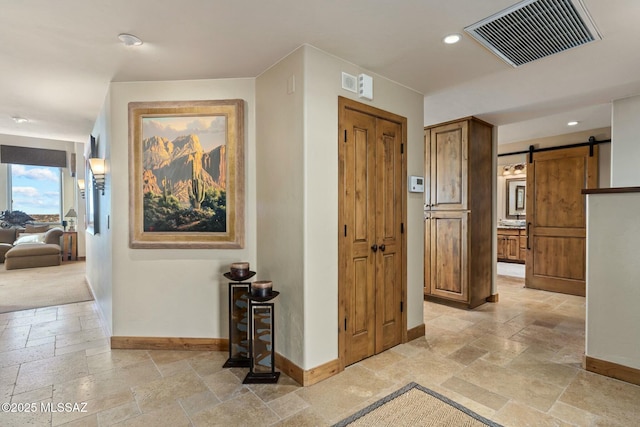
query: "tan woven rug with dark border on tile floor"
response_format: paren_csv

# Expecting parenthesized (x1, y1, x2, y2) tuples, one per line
(334, 383, 501, 427)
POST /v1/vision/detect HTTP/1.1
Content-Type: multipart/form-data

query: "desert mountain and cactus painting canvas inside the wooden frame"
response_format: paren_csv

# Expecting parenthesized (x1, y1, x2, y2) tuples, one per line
(142, 115, 227, 232)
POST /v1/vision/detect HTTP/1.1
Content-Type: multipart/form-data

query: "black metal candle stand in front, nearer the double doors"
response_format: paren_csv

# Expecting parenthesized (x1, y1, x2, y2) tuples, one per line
(243, 291, 280, 384)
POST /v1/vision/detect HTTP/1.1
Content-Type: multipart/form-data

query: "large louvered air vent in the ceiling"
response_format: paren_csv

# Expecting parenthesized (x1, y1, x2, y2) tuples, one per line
(464, 0, 601, 67)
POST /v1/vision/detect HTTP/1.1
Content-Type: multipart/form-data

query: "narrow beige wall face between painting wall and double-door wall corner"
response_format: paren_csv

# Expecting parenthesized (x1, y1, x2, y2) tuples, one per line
(256, 49, 305, 366)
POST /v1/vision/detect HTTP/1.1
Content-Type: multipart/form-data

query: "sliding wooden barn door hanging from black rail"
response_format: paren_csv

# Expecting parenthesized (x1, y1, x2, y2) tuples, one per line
(525, 146, 598, 296)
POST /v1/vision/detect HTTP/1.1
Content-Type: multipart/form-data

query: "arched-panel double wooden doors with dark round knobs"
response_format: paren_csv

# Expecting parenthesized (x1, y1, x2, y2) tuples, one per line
(338, 98, 406, 366)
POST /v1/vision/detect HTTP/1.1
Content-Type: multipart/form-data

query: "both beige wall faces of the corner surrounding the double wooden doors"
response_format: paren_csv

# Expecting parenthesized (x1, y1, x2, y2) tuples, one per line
(256, 46, 424, 369)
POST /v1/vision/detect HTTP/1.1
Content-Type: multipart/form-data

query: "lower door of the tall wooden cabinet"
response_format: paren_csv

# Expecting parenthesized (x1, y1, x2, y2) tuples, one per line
(425, 212, 469, 302)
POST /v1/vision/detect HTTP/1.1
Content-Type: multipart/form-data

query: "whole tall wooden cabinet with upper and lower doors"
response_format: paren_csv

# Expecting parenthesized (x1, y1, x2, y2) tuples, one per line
(424, 117, 493, 308)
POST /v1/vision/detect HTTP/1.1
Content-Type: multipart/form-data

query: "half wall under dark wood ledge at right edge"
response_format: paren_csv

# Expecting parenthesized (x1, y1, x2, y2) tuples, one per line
(586, 193, 640, 369)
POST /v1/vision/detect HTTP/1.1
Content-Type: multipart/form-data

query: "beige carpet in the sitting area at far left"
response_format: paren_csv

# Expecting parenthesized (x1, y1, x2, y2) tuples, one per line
(0, 261, 93, 313)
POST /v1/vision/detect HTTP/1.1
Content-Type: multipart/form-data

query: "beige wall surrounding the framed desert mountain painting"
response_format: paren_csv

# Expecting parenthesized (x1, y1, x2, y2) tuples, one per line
(100, 79, 255, 338)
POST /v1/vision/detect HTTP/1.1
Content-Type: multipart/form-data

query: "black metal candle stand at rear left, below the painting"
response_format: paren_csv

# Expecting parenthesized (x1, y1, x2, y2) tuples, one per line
(222, 271, 256, 368)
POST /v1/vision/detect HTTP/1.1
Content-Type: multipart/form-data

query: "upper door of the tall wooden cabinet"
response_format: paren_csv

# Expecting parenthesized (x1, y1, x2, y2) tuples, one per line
(425, 121, 469, 210)
